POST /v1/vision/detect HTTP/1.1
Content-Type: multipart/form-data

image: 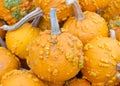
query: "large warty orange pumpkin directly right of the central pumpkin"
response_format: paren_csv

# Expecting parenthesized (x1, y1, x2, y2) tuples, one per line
(82, 37, 120, 86)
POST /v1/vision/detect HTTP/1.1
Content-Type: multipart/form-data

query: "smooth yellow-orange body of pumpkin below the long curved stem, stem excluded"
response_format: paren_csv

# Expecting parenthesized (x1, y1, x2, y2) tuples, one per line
(6, 23, 40, 59)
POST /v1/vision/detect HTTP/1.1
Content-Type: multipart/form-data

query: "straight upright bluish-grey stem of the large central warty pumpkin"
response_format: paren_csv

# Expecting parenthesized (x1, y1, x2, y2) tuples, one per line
(50, 8, 61, 35)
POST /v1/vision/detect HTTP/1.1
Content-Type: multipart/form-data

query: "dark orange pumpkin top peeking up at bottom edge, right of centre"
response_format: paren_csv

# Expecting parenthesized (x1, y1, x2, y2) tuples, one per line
(69, 78, 91, 86)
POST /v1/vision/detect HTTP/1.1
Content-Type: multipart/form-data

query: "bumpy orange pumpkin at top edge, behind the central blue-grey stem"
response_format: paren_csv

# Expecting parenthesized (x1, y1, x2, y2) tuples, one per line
(33, 0, 79, 21)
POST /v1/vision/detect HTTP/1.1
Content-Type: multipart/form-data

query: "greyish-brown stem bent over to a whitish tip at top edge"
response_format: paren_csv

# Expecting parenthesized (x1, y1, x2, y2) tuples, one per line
(66, 0, 85, 21)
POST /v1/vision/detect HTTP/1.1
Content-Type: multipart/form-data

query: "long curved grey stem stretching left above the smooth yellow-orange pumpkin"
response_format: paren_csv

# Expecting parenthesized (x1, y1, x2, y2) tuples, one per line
(0, 7, 43, 31)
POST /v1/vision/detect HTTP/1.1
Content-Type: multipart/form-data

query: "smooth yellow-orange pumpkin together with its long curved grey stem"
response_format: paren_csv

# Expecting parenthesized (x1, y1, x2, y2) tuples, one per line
(1, 8, 41, 59)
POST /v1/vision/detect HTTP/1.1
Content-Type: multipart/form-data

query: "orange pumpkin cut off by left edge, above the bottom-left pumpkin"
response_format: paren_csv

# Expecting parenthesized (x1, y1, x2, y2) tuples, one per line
(0, 47, 20, 80)
